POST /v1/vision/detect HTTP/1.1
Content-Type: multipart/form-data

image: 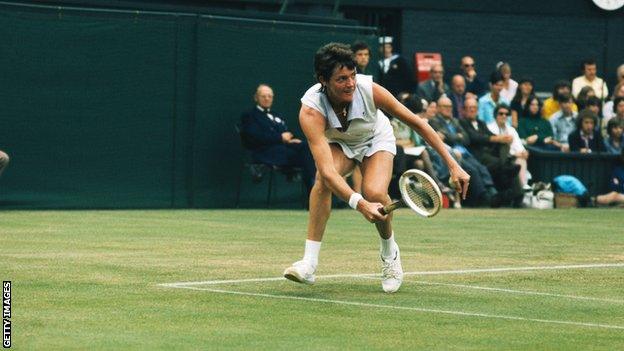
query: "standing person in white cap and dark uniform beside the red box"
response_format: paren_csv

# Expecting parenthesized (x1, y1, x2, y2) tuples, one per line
(379, 37, 414, 96)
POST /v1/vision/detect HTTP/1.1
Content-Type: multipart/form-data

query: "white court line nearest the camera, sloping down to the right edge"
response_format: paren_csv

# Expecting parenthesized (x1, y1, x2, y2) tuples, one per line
(170, 286, 624, 330)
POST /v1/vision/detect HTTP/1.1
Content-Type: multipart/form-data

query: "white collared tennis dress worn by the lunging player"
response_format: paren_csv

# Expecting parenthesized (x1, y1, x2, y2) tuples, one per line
(301, 74, 396, 162)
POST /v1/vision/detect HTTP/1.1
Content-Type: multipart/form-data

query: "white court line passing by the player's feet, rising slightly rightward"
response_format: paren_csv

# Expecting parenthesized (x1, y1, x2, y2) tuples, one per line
(158, 263, 624, 287)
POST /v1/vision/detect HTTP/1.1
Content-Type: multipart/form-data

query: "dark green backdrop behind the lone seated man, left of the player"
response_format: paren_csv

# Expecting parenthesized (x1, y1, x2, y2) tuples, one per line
(0, 5, 374, 208)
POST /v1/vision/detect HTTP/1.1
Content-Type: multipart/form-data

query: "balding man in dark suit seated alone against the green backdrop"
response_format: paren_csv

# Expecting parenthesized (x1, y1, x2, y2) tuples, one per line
(241, 84, 316, 195)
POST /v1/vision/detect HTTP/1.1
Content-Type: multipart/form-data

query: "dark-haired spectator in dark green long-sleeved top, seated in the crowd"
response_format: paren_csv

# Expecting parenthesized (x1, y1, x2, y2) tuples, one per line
(518, 95, 561, 151)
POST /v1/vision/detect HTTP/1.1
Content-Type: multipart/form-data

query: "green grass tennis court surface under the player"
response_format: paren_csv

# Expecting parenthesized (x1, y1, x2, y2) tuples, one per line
(0, 209, 624, 350)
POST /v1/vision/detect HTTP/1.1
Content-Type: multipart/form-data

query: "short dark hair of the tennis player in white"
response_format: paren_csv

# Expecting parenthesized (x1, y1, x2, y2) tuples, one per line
(314, 43, 356, 81)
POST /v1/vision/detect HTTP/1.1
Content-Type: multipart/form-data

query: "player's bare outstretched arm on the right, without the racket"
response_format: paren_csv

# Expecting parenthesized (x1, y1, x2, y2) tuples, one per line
(373, 83, 470, 199)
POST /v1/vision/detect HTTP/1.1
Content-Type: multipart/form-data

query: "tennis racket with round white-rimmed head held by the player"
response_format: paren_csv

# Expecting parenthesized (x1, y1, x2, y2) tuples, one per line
(379, 169, 442, 217)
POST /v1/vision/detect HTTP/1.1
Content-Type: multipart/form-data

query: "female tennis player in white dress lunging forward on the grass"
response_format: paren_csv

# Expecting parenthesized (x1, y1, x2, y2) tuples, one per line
(284, 43, 470, 292)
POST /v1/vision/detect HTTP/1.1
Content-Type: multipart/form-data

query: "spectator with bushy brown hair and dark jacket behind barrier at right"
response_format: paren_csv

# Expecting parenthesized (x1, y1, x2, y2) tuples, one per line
(568, 110, 606, 154)
